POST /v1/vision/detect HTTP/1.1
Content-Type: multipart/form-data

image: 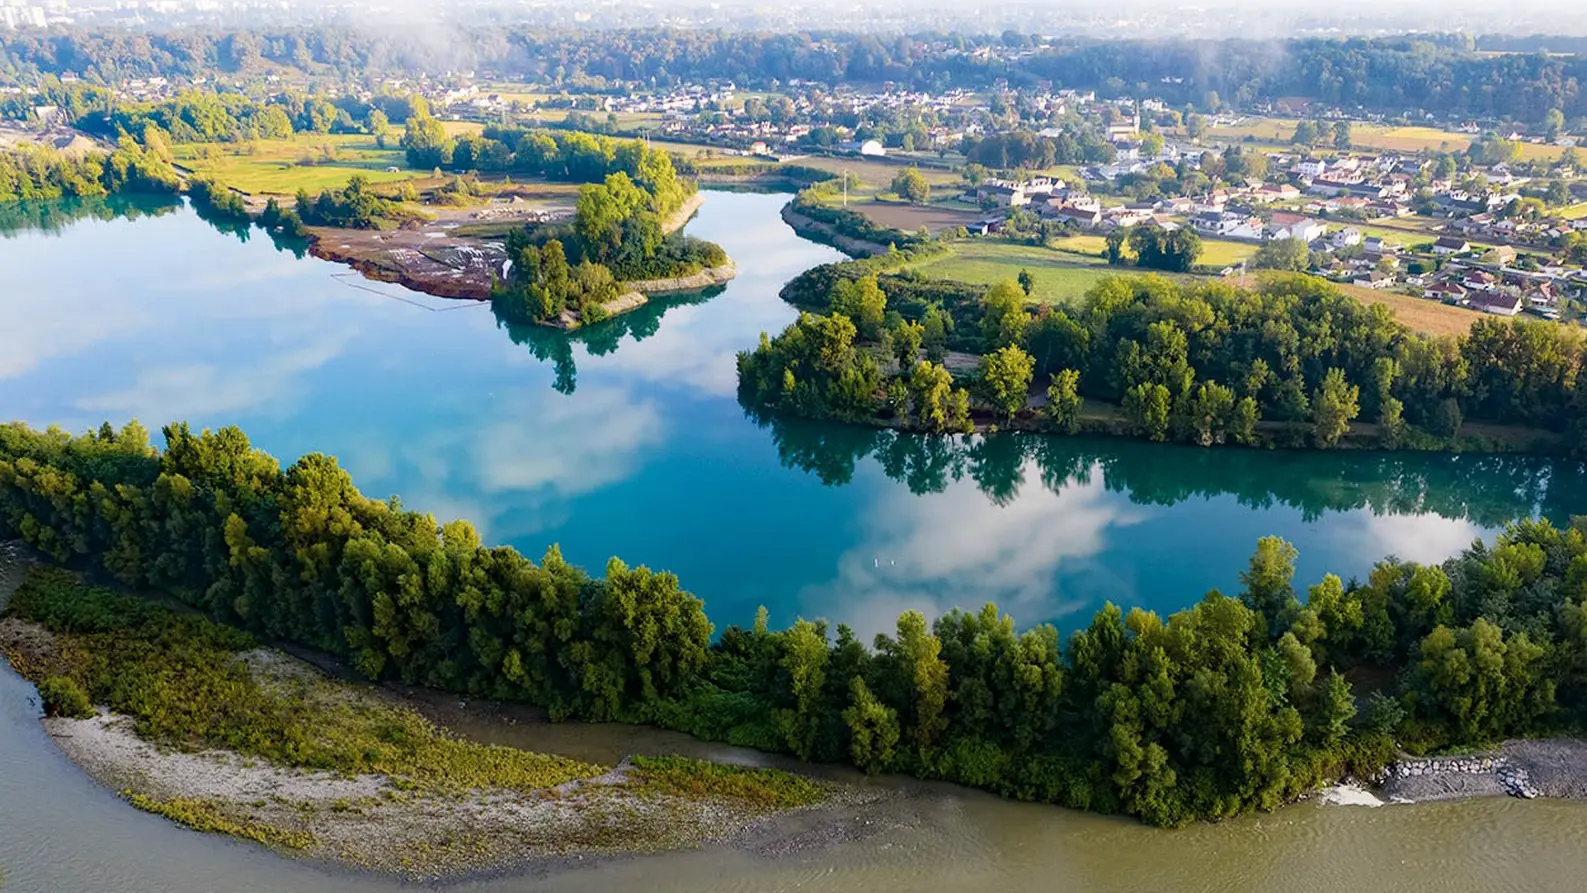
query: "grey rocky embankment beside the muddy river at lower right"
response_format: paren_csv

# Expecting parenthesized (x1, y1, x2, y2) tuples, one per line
(1371, 738, 1587, 803)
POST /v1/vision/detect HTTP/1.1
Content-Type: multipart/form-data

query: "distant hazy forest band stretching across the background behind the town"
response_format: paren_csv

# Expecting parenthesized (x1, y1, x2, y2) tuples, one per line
(0, 27, 1587, 122)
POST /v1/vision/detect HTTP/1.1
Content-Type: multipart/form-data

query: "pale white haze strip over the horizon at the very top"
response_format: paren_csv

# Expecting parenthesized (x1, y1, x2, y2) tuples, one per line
(27, 0, 1587, 38)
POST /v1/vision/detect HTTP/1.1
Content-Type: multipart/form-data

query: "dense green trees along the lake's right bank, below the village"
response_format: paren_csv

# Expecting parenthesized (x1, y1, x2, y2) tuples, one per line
(740, 265, 1587, 454)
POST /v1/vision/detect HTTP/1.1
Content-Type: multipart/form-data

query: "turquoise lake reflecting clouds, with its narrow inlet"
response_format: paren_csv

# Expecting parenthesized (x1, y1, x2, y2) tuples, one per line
(0, 192, 1587, 634)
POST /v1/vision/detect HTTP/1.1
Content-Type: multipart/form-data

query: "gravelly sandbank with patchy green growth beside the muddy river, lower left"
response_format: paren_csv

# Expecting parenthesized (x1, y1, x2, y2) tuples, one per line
(0, 544, 897, 880)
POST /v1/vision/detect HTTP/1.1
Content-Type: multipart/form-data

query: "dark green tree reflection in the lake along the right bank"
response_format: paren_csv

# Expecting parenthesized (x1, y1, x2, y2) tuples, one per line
(746, 409, 1587, 527)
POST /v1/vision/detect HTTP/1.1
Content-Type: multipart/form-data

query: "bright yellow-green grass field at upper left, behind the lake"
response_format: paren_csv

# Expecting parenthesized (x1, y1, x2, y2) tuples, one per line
(175, 132, 415, 195)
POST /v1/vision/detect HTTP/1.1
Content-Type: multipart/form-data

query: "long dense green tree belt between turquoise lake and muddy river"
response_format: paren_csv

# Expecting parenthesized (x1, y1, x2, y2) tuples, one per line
(9, 425, 1587, 825)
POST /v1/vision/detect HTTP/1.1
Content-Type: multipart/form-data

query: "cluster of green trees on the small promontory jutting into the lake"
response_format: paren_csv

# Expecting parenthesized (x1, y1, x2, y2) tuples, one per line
(487, 130, 728, 322)
